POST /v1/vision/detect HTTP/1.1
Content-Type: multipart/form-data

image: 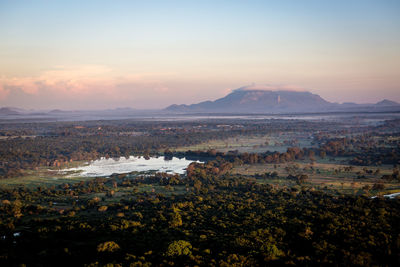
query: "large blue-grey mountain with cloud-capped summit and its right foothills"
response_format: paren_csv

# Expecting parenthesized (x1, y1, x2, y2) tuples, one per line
(165, 85, 400, 113)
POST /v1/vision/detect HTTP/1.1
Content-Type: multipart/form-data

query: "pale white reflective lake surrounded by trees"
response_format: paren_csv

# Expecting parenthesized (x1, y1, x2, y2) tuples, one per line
(60, 156, 200, 177)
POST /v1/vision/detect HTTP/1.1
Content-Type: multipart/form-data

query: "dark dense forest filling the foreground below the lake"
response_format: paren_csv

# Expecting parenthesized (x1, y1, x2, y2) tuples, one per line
(0, 160, 400, 266)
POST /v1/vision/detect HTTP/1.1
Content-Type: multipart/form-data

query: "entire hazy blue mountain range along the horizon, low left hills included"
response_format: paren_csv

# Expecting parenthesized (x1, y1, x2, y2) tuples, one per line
(0, 85, 400, 118)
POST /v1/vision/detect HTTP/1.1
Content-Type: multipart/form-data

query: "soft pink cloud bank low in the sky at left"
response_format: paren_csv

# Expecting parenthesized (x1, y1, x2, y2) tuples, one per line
(0, 65, 169, 109)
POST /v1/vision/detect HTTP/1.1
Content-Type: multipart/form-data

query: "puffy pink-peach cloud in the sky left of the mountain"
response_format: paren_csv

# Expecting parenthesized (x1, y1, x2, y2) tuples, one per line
(0, 65, 173, 108)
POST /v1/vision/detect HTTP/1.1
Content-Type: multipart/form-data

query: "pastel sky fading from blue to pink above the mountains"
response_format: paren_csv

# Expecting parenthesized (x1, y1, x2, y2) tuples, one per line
(0, 0, 400, 109)
